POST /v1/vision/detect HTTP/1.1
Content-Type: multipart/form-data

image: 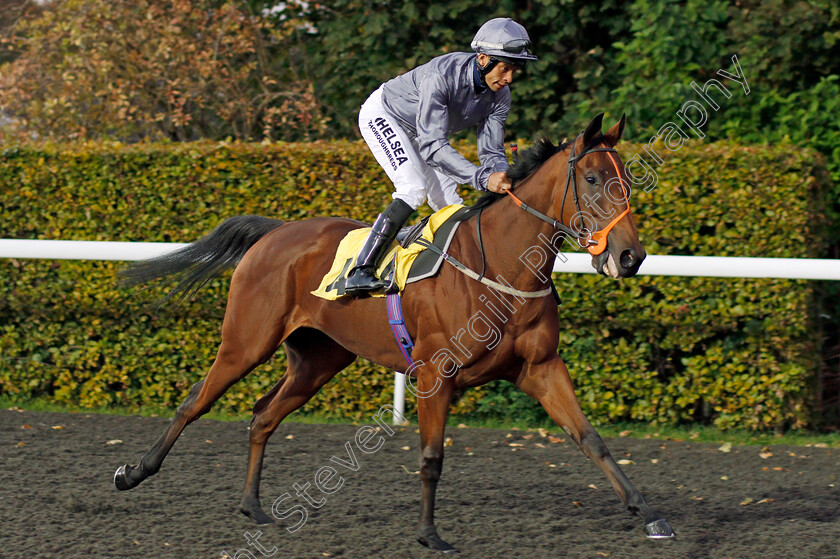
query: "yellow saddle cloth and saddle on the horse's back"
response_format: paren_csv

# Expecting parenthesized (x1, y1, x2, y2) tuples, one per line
(312, 204, 475, 301)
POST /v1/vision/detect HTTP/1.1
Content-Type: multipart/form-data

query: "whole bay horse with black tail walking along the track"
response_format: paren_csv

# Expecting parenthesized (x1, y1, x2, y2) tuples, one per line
(114, 114, 674, 552)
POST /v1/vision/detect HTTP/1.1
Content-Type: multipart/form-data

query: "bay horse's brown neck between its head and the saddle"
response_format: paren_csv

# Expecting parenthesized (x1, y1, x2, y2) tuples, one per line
(482, 164, 565, 291)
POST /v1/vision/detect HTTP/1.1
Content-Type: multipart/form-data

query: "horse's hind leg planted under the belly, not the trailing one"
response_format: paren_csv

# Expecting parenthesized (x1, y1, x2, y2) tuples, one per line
(240, 328, 356, 524)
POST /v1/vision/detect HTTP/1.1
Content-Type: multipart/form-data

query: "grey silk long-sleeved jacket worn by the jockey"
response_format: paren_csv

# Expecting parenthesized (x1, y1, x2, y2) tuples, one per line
(382, 52, 510, 190)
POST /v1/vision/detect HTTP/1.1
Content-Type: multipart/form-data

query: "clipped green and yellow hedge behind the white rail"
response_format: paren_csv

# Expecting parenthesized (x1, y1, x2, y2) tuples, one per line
(0, 142, 826, 428)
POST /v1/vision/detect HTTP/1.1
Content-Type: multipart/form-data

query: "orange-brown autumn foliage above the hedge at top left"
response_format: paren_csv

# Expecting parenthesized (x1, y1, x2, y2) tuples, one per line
(0, 0, 324, 140)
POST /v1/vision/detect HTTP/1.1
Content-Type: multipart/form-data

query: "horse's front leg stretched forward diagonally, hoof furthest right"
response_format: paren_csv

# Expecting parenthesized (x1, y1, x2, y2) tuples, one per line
(517, 357, 675, 539)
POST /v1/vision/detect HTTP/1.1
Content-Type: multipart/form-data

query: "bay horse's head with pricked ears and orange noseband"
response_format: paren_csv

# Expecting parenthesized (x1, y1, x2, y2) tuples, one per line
(554, 113, 646, 278)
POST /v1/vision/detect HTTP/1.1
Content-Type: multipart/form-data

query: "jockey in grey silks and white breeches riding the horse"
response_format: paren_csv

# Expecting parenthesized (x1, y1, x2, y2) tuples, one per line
(344, 18, 537, 295)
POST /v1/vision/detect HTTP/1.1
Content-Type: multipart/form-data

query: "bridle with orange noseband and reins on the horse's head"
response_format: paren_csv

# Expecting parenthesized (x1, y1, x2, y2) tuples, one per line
(506, 138, 630, 256)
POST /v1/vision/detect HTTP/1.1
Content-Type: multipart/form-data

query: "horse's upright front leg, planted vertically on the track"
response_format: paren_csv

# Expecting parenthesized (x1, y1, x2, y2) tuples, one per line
(417, 370, 457, 553)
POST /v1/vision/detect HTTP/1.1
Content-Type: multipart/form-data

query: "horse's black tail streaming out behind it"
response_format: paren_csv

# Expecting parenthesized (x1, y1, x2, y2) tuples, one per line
(119, 215, 284, 303)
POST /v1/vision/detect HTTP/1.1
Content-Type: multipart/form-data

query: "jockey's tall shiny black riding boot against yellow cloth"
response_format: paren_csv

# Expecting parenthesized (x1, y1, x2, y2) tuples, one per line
(344, 200, 414, 295)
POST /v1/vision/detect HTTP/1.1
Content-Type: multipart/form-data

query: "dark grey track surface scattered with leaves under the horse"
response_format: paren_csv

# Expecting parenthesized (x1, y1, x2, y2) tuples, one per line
(0, 410, 840, 559)
